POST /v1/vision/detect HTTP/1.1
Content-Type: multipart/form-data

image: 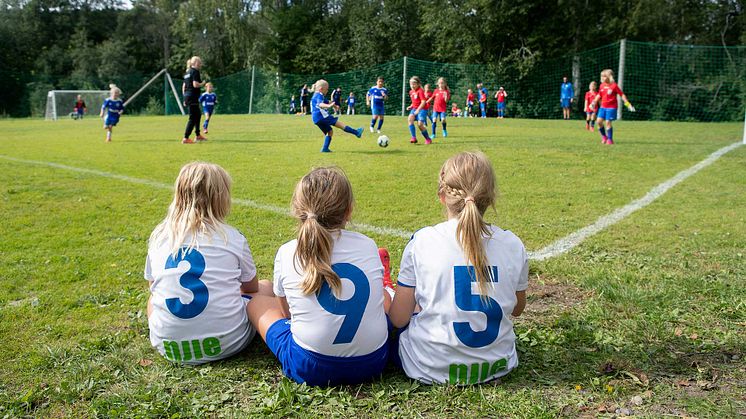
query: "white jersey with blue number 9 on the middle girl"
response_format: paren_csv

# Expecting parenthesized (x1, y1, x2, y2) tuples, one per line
(274, 230, 388, 357)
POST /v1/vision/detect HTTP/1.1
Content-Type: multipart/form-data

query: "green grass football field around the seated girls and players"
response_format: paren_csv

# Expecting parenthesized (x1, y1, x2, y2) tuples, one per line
(0, 115, 746, 417)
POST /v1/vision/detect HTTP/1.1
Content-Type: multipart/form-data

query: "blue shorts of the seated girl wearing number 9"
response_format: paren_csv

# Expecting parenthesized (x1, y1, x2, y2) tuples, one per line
(266, 319, 389, 387)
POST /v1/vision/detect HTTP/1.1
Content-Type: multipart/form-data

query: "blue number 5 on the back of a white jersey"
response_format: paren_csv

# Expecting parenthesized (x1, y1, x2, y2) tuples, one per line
(453, 266, 503, 348)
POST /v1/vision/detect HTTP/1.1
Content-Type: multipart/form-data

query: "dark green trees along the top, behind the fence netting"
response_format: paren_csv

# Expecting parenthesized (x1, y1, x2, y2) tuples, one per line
(0, 0, 746, 116)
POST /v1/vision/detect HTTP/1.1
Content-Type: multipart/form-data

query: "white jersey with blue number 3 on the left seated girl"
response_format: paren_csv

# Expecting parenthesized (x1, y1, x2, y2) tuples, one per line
(145, 224, 256, 364)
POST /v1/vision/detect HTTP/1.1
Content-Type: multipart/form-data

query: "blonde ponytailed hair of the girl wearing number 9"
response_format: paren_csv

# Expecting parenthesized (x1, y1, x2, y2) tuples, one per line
(291, 167, 354, 295)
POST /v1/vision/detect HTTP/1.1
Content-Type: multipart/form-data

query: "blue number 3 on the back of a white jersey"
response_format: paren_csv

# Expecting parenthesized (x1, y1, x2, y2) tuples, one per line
(166, 247, 210, 319)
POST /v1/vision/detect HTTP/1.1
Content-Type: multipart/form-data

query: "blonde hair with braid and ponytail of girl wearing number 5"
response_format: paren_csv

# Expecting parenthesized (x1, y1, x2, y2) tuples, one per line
(438, 152, 497, 297)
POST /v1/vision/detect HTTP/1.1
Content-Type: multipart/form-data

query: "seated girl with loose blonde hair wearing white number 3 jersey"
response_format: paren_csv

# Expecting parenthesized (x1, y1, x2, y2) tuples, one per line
(145, 162, 272, 364)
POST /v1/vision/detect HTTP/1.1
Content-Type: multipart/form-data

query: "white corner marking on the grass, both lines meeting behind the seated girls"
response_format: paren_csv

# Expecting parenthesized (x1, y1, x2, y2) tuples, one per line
(0, 143, 743, 260)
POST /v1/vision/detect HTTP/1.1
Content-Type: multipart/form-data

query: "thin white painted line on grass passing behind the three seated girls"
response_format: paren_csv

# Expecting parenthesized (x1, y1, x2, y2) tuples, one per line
(0, 154, 412, 239)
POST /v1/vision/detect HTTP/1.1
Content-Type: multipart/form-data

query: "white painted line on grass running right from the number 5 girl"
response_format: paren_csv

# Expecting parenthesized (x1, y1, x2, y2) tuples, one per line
(528, 143, 742, 260)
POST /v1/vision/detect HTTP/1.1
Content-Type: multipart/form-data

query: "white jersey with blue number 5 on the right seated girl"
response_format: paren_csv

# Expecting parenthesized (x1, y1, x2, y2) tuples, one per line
(398, 219, 528, 384)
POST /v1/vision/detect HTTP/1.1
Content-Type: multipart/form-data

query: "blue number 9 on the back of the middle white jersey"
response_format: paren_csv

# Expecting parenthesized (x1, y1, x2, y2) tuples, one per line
(316, 263, 370, 345)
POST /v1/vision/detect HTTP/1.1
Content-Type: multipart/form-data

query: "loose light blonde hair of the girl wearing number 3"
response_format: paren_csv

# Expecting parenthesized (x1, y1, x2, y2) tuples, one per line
(150, 161, 231, 256)
